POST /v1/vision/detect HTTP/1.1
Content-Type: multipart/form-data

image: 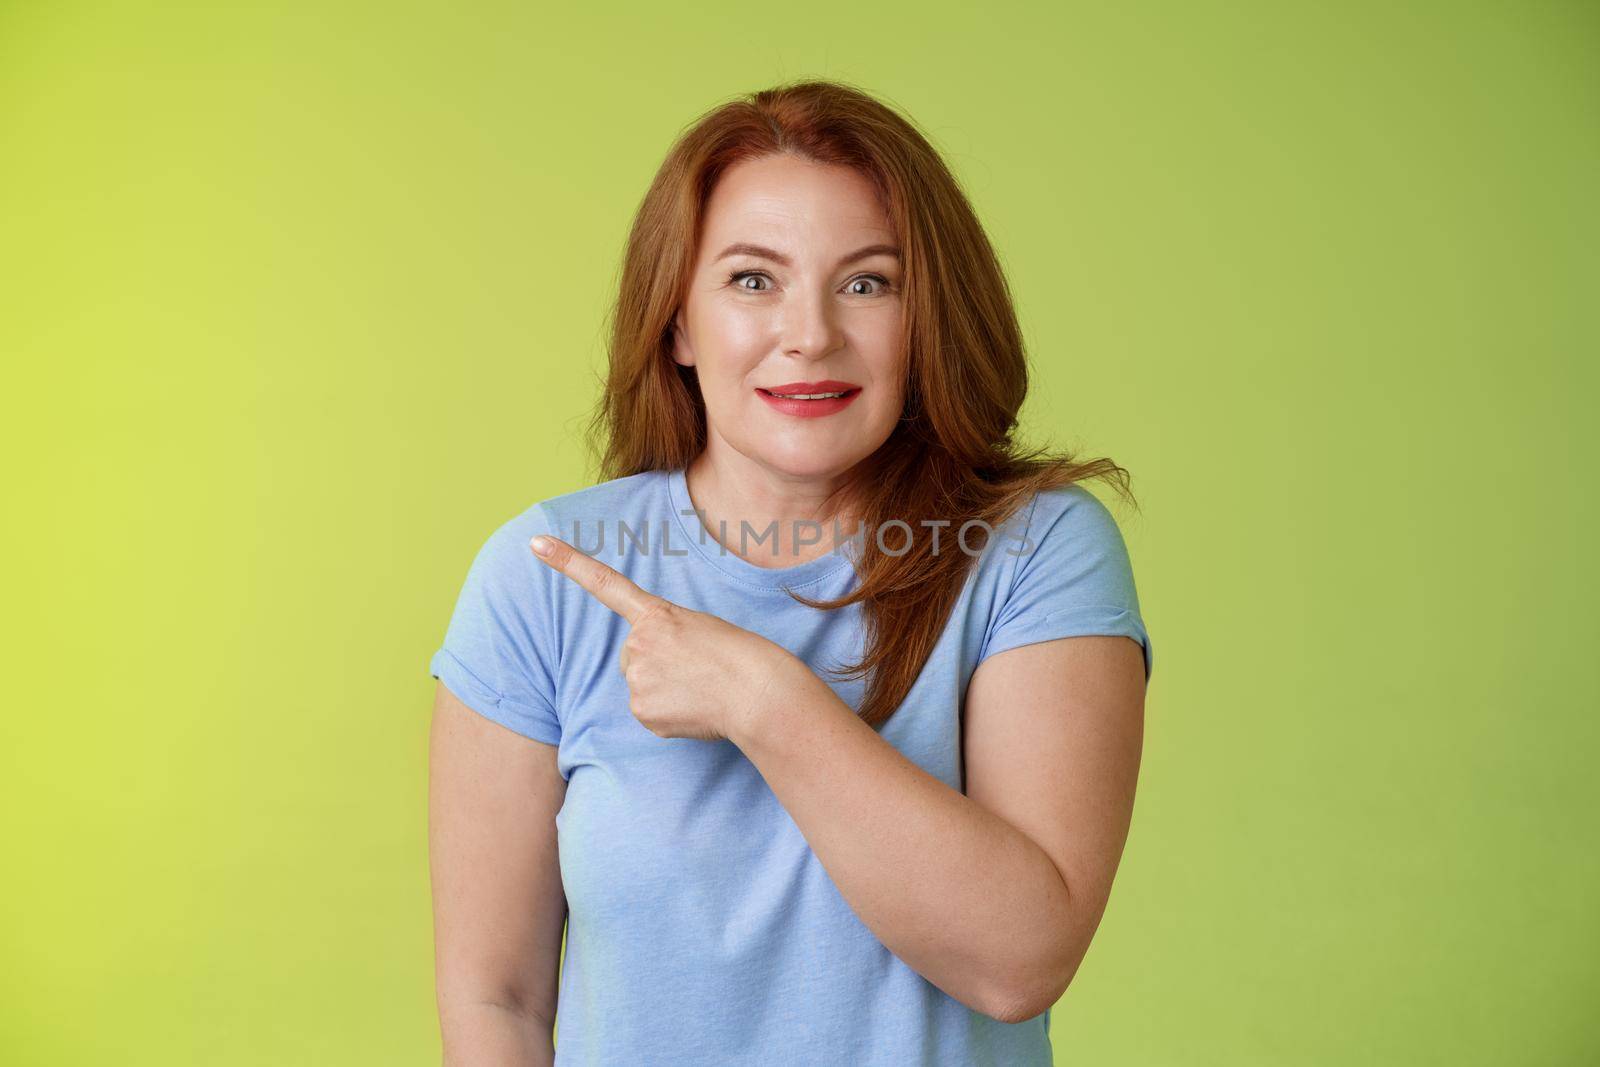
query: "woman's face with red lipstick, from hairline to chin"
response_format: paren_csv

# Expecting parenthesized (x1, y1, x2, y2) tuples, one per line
(674, 155, 904, 477)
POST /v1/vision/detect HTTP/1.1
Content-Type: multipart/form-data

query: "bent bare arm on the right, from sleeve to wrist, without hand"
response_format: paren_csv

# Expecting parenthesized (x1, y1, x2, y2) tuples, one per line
(731, 635, 1144, 1022)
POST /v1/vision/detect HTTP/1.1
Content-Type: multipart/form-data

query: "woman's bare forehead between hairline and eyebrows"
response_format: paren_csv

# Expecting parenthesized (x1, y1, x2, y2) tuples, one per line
(704, 155, 894, 246)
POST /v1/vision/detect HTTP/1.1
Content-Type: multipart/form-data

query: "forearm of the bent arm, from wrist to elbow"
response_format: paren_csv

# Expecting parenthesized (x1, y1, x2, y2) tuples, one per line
(730, 678, 1082, 1021)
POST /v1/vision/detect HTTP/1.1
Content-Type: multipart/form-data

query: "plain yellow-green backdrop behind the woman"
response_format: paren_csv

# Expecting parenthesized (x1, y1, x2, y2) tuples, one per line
(0, 2, 1600, 1065)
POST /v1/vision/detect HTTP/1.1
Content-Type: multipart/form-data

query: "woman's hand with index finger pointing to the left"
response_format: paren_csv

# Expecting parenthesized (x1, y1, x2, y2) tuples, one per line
(528, 536, 821, 741)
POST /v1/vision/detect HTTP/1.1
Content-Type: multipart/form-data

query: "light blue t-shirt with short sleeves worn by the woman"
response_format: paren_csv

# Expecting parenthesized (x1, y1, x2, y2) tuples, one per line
(429, 469, 1152, 1067)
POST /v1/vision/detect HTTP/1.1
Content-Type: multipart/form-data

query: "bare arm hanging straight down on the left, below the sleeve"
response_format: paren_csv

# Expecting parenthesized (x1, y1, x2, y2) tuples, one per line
(427, 683, 566, 1067)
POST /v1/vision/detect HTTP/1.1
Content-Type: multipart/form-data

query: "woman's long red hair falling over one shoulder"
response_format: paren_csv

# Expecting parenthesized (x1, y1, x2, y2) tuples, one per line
(590, 80, 1138, 726)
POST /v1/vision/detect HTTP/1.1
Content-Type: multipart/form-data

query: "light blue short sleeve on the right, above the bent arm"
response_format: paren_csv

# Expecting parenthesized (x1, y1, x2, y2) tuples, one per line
(978, 485, 1155, 681)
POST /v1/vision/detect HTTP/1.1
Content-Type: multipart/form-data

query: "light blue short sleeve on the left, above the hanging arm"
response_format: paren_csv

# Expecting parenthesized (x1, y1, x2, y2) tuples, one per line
(429, 504, 562, 745)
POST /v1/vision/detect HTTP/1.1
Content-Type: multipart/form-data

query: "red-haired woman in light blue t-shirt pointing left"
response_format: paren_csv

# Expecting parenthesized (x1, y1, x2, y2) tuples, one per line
(430, 82, 1150, 1065)
